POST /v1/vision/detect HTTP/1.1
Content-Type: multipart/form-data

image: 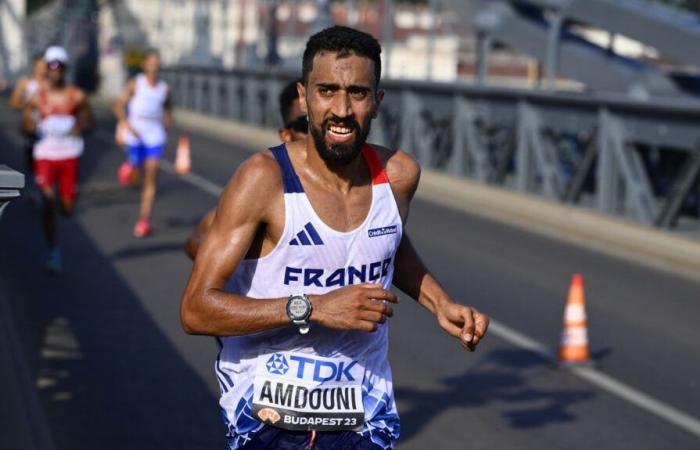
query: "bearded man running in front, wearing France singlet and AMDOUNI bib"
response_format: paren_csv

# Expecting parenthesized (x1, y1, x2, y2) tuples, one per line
(181, 27, 489, 450)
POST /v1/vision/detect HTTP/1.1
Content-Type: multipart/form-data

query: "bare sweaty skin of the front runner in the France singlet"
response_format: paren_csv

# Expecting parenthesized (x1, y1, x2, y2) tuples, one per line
(181, 52, 488, 350)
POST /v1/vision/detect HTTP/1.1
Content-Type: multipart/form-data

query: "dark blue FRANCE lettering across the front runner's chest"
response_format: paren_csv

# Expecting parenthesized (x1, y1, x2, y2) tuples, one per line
(284, 258, 391, 287)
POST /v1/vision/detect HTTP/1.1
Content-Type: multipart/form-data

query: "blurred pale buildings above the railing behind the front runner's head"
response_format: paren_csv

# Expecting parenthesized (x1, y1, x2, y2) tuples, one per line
(99, 0, 468, 95)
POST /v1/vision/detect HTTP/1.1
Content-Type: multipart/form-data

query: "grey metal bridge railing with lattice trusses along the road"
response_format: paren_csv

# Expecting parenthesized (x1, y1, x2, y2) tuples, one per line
(164, 67, 700, 234)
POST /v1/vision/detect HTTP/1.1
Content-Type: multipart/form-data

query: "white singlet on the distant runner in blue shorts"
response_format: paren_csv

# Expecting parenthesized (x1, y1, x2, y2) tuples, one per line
(124, 73, 168, 147)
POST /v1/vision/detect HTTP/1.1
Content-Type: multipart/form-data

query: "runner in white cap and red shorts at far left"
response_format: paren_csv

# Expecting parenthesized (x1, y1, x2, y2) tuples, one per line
(24, 46, 93, 272)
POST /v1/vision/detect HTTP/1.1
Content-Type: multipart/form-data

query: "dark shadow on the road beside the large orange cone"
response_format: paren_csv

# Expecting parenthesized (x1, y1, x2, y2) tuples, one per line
(396, 350, 595, 442)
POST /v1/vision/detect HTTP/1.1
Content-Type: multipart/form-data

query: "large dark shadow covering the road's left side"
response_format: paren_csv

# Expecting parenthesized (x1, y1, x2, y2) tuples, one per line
(0, 117, 226, 450)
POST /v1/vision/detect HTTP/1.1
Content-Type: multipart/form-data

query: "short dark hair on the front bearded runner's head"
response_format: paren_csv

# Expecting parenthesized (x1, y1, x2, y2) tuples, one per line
(301, 25, 382, 86)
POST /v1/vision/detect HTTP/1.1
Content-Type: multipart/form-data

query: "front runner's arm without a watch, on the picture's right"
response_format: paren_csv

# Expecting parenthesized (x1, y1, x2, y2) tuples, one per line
(387, 151, 489, 351)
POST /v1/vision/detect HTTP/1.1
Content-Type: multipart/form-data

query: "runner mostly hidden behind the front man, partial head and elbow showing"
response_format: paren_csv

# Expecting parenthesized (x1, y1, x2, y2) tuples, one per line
(185, 81, 309, 260)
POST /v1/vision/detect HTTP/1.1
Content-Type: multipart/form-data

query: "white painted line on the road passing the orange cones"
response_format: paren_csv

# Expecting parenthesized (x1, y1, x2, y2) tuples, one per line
(96, 125, 700, 437)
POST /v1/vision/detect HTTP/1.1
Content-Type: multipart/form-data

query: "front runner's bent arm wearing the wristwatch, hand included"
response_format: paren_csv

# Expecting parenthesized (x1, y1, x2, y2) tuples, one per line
(180, 153, 398, 336)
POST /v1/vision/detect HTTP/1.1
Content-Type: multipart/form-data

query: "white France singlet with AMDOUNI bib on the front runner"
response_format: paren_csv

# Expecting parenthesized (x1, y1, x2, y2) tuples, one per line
(215, 144, 403, 449)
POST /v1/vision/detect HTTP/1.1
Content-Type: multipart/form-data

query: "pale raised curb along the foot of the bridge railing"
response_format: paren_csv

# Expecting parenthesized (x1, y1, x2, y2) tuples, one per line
(150, 105, 700, 281)
